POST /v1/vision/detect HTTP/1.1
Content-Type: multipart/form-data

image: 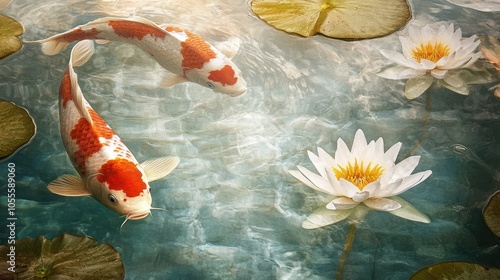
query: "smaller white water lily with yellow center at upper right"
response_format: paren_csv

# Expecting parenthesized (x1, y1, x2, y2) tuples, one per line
(378, 24, 481, 99)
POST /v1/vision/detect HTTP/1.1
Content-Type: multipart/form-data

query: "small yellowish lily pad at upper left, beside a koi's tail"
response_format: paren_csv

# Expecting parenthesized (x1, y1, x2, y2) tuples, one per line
(0, 15, 24, 58)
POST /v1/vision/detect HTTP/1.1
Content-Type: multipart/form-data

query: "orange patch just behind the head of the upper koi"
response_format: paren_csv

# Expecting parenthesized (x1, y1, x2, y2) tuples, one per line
(165, 26, 217, 70)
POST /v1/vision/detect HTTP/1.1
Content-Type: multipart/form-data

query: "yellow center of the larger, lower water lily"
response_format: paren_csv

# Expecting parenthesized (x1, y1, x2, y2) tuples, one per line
(333, 160, 384, 190)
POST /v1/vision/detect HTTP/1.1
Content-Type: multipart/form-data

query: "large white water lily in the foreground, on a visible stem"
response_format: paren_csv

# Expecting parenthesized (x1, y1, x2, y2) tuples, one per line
(289, 130, 432, 229)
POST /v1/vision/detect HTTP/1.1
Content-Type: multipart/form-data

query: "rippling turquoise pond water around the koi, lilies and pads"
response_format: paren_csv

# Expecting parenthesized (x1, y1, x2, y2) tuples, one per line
(0, 0, 500, 279)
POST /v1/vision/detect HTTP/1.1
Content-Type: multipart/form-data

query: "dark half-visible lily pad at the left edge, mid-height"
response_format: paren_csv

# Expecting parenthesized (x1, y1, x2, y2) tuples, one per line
(0, 100, 36, 160)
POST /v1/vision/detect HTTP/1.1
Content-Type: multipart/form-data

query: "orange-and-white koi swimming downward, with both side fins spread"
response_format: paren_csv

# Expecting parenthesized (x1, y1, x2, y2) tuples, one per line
(48, 40, 179, 225)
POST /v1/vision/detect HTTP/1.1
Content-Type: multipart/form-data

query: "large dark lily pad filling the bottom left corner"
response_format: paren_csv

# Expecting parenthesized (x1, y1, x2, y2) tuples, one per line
(0, 234, 125, 279)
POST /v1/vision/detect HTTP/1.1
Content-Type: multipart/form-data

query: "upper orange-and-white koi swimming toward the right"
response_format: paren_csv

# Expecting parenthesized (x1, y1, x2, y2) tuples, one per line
(31, 16, 247, 96)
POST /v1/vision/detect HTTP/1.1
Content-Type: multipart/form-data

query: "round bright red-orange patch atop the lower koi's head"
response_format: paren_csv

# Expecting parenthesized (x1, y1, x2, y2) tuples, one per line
(97, 158, 146, 197)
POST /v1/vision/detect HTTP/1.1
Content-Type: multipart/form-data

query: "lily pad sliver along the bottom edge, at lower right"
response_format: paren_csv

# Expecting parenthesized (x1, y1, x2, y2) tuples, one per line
(410, 261, 500, 280)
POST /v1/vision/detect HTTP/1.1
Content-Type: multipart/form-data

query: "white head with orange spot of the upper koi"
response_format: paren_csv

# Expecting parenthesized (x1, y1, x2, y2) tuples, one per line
(184, 55, 247, 96)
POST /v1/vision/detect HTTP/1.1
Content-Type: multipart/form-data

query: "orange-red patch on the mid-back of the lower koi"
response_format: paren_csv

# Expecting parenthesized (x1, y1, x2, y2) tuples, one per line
(70, 108, 115, 172)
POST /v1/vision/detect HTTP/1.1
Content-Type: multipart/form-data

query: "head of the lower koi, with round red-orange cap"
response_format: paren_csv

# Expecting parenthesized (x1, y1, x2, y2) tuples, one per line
(89, 159, 152, 220)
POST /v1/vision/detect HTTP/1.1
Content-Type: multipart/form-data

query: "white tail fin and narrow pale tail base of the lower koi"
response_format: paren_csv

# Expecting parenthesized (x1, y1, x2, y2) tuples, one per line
(69, 40, 94, 124)
